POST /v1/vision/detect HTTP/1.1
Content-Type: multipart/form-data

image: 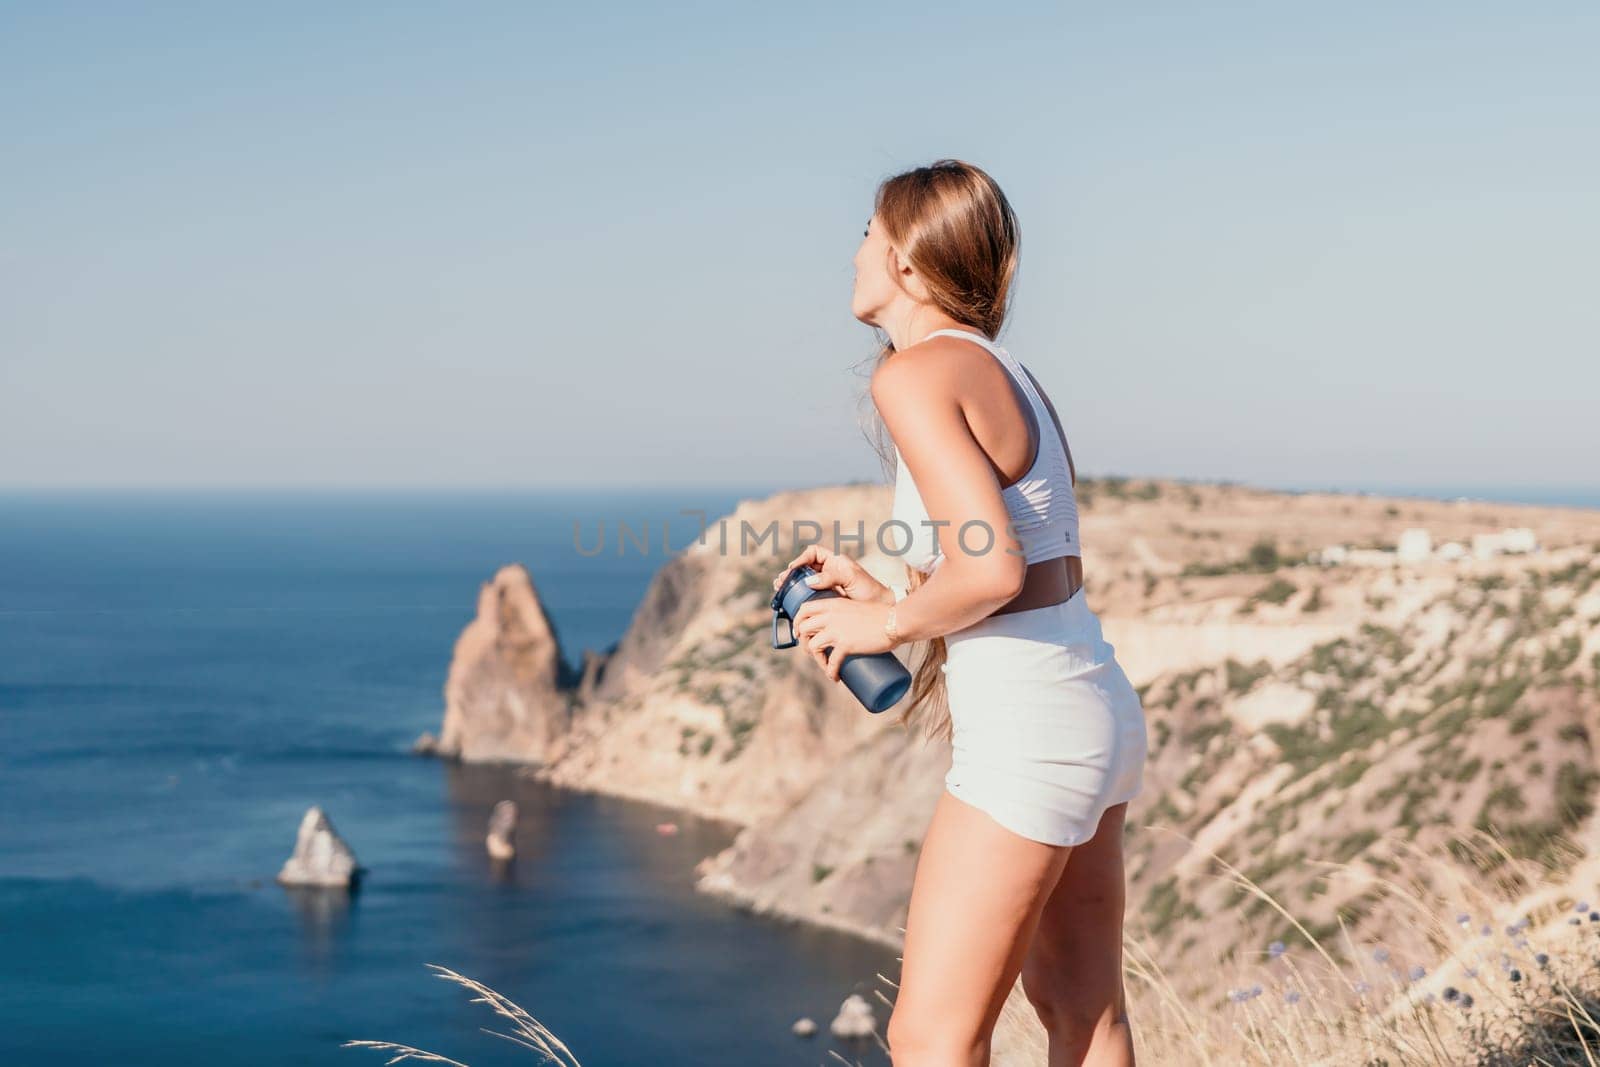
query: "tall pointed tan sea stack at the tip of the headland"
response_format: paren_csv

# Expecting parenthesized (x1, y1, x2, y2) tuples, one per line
(438, 563, 578, 763)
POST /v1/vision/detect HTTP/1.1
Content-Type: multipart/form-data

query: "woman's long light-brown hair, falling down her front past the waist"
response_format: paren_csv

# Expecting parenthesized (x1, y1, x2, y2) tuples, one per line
(867, 160, 1019, 741)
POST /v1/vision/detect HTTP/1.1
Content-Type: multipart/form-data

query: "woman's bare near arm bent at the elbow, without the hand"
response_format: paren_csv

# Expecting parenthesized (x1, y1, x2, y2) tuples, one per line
(872, 349, 1027, 641)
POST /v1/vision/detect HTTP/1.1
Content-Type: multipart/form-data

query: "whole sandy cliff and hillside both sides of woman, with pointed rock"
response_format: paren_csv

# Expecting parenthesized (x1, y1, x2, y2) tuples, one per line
(445, 480, 1600, 979)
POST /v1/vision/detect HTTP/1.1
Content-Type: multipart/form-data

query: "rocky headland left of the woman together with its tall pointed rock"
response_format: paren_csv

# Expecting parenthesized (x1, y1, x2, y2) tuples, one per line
(440, 486, 949, 844)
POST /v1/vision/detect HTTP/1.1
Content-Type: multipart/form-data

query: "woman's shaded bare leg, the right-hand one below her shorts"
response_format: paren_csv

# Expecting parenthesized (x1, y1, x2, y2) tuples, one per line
(1022, 803, 1133, 1067)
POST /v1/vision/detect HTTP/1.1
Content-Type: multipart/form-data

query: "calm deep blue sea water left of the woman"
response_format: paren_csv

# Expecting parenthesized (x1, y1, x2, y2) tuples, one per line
(0, 491, 896, 1067)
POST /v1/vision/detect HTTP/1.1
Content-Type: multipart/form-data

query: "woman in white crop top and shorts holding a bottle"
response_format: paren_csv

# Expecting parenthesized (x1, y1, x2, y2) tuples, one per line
(774, 160, 1146, 1067)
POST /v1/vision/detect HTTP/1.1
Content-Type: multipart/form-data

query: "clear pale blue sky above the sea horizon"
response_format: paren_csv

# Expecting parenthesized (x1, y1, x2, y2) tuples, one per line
(0, 3, 1600, 486)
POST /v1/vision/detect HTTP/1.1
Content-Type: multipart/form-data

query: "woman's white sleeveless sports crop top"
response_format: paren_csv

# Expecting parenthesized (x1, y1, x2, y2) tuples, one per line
(890, 330, 1082, 574)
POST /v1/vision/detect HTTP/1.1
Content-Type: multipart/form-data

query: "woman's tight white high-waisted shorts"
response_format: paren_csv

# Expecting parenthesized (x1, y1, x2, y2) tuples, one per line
(942, 589, 1147, 845)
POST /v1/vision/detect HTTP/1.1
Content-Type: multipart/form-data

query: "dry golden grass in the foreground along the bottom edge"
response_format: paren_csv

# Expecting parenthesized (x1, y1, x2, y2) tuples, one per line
(344, 833, 1600, 1067)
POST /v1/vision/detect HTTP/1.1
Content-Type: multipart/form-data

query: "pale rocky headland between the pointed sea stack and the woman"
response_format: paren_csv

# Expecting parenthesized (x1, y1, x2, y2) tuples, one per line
(534, 486, 934, 824)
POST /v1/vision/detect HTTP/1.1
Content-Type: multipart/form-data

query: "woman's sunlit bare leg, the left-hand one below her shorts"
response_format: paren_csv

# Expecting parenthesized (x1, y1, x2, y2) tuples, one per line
(888, 792, 1072, 1067)
